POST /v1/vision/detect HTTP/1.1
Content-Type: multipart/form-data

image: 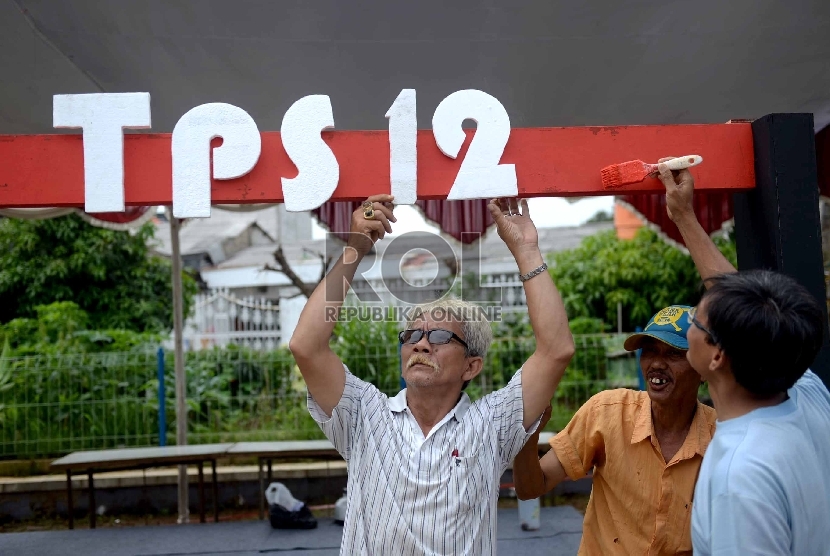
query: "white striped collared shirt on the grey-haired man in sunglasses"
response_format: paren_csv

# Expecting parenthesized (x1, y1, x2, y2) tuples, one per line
(308, 365, 537, 556)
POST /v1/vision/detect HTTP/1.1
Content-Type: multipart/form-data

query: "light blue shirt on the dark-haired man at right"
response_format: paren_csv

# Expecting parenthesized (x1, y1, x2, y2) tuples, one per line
(692, 370, 830, 556)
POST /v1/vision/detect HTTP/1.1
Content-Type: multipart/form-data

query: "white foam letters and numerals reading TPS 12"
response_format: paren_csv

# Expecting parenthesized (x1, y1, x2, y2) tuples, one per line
(53, 89, 518, 218)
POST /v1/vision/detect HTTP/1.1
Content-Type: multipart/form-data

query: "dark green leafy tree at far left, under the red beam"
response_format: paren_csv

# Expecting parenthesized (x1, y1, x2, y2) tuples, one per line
(0, 215, 198, 332)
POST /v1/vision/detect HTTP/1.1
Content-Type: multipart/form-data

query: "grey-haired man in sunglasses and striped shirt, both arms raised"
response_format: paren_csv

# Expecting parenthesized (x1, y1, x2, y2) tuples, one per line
(290, 195, 574, 555)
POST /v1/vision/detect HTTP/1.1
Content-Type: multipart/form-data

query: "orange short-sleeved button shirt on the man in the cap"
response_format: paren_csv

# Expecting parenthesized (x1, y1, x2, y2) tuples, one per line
(550, 389, 717, 556)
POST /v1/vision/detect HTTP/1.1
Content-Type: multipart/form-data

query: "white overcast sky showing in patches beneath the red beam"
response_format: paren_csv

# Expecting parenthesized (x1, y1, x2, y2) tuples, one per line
(312, 196, 614, 239)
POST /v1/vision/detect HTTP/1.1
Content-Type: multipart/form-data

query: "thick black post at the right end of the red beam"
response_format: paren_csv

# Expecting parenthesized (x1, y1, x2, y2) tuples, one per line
(734, 114, 830, 385)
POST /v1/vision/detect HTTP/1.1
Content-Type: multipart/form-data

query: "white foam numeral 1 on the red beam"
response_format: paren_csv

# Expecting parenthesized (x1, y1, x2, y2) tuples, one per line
(386, 89, 418, 205)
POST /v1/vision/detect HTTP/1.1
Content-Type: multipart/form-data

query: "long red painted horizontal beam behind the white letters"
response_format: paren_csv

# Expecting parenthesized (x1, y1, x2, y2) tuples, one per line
(0, 122, 755, 208)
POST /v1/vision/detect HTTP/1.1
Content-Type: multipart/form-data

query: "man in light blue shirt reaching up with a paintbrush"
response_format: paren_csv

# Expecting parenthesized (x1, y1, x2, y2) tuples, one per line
(660, 159, 830, 556)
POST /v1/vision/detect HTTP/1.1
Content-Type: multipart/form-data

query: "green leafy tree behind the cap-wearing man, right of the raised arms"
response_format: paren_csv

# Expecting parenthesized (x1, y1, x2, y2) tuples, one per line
(550, 228, 735, 330)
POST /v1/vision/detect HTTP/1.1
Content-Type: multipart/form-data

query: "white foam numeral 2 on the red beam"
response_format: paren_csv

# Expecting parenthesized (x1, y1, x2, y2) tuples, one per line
(432, 89, 518, 200)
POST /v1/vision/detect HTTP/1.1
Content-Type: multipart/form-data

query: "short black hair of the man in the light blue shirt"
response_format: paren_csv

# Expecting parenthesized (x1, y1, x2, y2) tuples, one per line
(703, 270, 824, 398)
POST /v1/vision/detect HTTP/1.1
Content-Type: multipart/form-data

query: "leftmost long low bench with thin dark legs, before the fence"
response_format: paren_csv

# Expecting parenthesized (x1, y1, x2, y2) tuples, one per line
(52, 444, 233, 529)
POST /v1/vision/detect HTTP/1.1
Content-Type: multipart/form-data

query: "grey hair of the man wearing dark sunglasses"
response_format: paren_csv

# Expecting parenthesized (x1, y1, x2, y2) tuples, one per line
(407, 297, 493, 357)
